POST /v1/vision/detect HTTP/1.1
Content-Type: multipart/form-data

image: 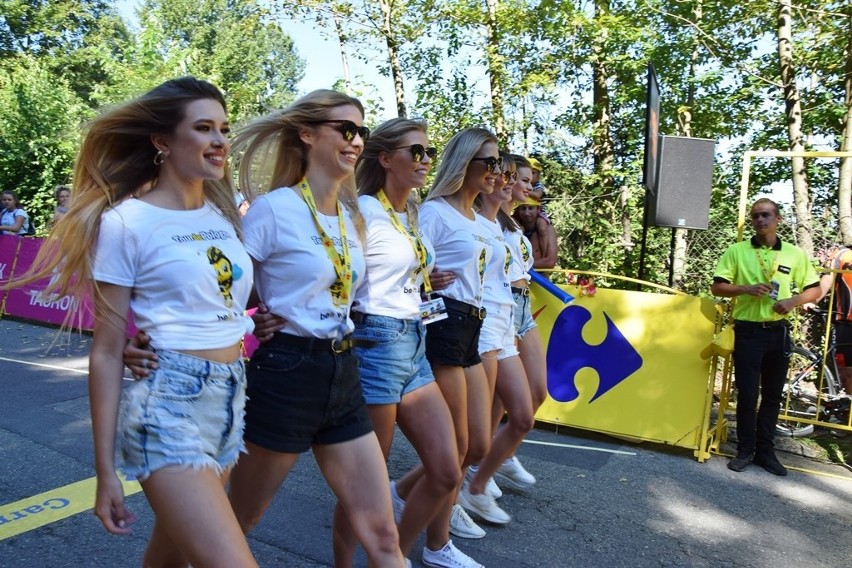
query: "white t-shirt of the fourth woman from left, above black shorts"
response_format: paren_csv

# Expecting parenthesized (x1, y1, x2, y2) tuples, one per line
(420, 197, 491, 307)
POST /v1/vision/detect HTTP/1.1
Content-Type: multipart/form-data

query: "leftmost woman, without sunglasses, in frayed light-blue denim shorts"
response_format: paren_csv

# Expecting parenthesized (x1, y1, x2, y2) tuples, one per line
(6, 77, 257, 567)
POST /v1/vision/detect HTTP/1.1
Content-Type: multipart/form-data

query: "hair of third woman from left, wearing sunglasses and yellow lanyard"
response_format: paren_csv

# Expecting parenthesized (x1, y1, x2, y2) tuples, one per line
(355, 118, 428, 225)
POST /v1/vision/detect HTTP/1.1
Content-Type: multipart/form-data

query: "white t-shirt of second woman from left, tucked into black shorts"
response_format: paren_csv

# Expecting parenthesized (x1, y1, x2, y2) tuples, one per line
(243, 187, 365, 339)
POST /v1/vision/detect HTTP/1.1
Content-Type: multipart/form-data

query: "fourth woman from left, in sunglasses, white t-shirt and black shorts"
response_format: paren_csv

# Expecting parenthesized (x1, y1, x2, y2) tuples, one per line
(397, 128, 500, 566)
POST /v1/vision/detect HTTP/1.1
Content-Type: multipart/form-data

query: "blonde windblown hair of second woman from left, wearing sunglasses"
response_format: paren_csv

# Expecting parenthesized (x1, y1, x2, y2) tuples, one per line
(231, 89, 366, 243)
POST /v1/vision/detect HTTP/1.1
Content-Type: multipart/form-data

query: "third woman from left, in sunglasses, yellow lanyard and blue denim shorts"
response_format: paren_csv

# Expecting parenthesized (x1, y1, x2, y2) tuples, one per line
(335, 118, 461, 566)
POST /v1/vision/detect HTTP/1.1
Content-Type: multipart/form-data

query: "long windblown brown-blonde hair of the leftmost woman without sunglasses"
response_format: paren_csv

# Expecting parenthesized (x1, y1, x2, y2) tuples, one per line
(7, 77, 241, 324)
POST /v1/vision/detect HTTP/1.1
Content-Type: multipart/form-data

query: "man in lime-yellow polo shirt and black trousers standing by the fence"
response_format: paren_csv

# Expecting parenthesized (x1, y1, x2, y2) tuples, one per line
(710, 198, 820, 475)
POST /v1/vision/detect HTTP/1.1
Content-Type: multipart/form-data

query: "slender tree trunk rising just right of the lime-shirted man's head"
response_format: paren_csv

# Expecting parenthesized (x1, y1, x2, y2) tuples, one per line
(778, 0, 814, 257)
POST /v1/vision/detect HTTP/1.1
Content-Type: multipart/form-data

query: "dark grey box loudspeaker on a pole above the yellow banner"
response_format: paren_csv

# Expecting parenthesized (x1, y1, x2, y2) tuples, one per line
(648, 136, 716, 229)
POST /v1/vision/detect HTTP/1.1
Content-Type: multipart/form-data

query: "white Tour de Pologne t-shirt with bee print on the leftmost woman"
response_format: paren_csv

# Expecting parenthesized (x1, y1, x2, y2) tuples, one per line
(92, 199, 254, 349)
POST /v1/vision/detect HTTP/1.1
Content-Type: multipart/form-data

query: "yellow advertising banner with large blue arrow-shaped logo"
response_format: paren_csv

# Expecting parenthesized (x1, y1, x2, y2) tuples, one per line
(532, 284, 717, 449)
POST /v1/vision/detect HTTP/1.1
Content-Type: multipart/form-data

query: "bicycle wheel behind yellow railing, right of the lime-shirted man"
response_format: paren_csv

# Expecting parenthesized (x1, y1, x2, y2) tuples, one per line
(775, 347, 835, 438)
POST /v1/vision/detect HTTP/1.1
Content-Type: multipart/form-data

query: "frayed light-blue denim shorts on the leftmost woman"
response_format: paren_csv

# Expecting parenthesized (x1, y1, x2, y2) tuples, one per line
(118, 350, 246, 481)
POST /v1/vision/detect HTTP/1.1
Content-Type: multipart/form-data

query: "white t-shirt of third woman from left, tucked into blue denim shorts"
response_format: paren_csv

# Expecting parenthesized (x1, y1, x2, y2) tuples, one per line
(352, 195, 435, 319)
